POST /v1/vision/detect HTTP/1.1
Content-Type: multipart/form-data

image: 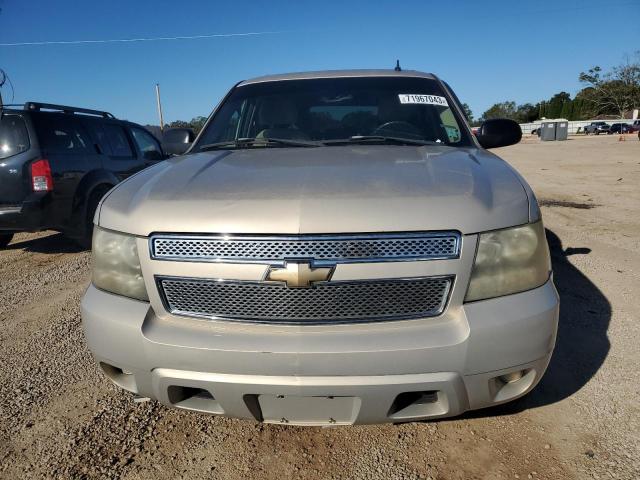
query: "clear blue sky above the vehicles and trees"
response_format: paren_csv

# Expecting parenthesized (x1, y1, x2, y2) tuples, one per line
(0, 0, 640, 123)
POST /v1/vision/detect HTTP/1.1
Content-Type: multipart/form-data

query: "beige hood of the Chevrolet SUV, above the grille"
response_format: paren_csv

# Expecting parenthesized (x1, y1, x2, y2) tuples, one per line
(98, 145, 529, 236)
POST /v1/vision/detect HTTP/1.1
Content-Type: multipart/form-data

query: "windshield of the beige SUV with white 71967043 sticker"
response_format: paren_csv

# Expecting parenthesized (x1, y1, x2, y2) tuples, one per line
(192, 77, 472, 152)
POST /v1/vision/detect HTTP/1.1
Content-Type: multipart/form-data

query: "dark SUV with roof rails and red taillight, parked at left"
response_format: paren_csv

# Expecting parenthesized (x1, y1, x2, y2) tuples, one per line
(0, 102, 166, 248)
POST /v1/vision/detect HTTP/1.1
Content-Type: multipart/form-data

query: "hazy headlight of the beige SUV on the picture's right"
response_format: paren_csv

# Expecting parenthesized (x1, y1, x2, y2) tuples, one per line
(465, 221, 551, 302)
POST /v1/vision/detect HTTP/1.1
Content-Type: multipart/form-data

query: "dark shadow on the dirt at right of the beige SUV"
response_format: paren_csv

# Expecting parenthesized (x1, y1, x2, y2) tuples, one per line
(450, 229, 611, 418)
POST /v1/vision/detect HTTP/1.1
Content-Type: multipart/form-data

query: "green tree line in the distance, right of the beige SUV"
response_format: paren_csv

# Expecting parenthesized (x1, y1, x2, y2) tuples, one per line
(463, 51, 640, 125)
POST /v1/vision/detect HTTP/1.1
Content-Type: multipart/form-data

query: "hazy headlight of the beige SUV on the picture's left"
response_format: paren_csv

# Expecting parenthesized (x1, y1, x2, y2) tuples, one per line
(91, 227, 149, 301)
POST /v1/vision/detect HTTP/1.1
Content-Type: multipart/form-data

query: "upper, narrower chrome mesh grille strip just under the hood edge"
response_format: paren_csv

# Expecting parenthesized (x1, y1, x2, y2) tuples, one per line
(151, 232, 460, 263)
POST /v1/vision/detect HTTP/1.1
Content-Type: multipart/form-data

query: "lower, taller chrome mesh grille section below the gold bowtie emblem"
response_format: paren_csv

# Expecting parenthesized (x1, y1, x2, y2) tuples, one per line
(157, 277, 453, 324)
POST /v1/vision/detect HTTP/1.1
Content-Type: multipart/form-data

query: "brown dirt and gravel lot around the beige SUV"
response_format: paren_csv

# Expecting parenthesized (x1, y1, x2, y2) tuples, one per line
(0, 136, 640, 479)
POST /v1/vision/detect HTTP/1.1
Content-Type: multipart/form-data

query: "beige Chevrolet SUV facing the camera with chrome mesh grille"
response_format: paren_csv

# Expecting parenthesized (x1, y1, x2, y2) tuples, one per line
(82, 70, 558, 425)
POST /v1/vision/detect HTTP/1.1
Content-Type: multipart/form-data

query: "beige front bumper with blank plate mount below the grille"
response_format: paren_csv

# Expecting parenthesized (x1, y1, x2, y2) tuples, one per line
(82, 280, 559, 425)
